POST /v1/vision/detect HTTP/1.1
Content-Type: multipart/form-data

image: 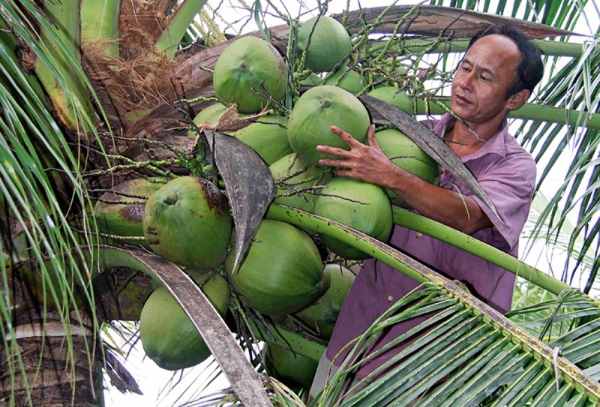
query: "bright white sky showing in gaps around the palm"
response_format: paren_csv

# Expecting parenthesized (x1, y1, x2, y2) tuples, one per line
(105, 0, 598, 407)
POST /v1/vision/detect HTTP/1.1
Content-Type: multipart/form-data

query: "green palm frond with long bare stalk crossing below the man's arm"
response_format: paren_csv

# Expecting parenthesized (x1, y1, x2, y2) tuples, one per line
(268, 205, 600, 406)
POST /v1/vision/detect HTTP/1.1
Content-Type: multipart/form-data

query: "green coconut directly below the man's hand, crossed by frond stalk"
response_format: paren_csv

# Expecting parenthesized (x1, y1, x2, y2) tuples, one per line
(315, 177, 393, 260)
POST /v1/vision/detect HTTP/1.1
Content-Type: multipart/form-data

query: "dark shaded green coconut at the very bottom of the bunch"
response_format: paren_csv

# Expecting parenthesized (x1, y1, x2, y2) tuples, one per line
(263, 344, 318, 390)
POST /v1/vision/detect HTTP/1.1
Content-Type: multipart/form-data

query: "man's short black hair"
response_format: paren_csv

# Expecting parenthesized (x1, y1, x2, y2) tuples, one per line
(467, 25, 544, 99)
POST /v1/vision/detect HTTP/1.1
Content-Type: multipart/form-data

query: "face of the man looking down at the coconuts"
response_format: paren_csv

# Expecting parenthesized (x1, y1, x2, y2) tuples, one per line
(452, 34, 521, 125)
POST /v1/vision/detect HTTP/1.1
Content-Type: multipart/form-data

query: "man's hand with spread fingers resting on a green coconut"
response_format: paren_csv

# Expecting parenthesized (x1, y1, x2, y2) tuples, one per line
(317, 124, 398, 188)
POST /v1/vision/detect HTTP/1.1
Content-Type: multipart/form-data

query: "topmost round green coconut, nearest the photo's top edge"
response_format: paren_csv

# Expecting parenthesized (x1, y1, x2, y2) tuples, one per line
(298, 16, 352, 72)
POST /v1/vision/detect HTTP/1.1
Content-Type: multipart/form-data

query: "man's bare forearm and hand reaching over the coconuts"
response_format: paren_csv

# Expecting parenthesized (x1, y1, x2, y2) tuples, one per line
(317, 125, 492, 234)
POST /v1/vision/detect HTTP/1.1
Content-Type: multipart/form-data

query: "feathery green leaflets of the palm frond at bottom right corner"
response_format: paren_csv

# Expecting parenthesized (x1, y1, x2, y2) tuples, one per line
(317, 283, 600, 406)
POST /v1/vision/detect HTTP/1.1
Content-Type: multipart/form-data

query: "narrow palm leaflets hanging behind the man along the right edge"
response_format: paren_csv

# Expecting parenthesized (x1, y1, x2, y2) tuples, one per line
(522, 36, 600, 292)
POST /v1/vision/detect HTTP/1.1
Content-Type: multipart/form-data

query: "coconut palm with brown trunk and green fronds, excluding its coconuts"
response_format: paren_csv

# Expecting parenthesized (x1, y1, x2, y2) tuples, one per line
(0, 0, 600, 406)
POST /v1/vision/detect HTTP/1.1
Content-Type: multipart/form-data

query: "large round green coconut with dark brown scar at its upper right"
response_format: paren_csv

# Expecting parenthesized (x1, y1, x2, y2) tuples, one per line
(143, 176, 232, 270)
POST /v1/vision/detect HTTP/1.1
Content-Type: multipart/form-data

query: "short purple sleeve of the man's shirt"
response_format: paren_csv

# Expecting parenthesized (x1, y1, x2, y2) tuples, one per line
(467, 153, 536, 251)
